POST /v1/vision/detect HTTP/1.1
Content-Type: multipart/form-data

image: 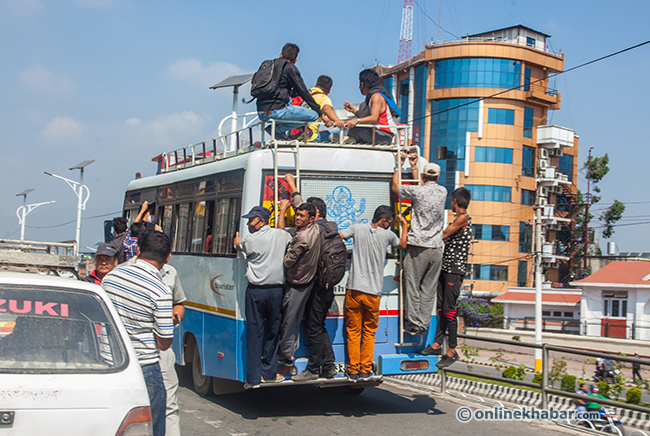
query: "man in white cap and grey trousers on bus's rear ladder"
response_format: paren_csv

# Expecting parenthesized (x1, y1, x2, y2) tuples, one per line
(391, 153, 447, 335)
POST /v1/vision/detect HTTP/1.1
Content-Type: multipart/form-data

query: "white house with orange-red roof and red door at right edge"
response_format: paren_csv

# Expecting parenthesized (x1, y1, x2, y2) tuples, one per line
(571, 261, 650, 340)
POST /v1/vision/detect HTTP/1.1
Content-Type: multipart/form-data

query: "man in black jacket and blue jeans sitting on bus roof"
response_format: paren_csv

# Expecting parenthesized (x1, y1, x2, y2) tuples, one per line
(253, 43, 322, 138)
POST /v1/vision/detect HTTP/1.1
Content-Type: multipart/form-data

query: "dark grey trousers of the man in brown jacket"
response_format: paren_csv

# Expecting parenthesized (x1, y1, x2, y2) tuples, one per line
(278, 280, 314, 359)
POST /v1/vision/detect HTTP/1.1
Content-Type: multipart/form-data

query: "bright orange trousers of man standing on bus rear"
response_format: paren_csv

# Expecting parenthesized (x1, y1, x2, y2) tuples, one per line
(345, 289, 381, 374)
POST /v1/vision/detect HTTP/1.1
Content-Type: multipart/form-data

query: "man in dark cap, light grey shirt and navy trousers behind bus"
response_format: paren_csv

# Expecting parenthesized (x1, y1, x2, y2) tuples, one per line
(234, 206, 291, 388)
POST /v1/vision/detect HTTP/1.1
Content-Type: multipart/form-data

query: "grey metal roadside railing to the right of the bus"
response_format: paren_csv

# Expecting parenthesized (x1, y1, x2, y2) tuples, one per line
(440, 333, 650, 413)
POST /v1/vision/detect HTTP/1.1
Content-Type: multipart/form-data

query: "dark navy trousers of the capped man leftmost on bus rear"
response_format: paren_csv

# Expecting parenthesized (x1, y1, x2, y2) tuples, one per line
(246, 284, 283, 386)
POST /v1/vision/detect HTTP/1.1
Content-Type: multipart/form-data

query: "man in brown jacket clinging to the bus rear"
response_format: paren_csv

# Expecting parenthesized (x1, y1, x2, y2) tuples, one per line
(278, 203, 321, 365)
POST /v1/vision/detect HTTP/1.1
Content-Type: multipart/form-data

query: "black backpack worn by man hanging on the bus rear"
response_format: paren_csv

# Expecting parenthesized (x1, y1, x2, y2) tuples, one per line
(315, 221, 348, 291)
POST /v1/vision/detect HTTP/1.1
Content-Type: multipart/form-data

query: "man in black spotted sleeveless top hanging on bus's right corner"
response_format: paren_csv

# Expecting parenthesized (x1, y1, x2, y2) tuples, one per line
(417, 187, 472, 369)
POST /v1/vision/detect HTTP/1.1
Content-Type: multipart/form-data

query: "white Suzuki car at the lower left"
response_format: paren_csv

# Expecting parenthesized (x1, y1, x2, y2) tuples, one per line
(0, 273, 152, 436)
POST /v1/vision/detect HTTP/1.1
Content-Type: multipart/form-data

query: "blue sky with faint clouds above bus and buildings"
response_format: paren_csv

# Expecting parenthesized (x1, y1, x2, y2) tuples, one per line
(0, 0, 650, 251)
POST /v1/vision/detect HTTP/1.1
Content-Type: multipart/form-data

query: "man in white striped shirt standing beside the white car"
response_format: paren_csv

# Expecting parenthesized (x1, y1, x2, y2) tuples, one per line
(102, 232, 174, 436)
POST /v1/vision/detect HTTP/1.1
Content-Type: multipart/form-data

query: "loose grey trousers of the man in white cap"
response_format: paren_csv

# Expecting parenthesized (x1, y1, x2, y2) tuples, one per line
(404, 245, 442, 329)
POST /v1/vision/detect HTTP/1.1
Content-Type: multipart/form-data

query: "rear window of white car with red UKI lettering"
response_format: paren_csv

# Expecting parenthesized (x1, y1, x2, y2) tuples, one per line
(0, 286, 126, 373)
